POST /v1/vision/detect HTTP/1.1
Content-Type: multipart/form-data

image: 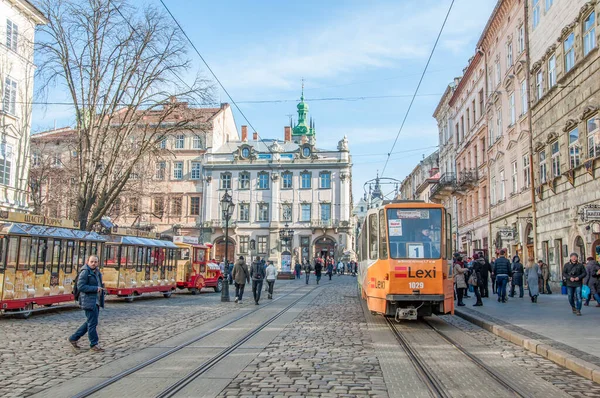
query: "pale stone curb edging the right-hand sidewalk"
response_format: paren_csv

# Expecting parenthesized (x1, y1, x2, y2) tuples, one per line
(454, 309, 600, 383)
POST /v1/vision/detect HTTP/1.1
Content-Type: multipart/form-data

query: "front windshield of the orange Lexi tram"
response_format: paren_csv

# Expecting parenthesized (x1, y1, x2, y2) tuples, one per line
(387, 209, 442, 259)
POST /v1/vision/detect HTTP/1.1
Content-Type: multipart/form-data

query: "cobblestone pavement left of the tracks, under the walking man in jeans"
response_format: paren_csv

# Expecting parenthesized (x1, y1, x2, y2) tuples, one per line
(0, 282, 300, 397)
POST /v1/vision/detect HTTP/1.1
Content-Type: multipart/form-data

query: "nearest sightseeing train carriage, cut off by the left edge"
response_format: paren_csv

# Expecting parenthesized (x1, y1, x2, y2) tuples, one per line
(0, 211, 106, 318)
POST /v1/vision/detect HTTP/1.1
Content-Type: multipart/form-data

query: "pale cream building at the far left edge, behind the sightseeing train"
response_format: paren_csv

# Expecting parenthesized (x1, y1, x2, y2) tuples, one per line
(0, 0, 47, 211)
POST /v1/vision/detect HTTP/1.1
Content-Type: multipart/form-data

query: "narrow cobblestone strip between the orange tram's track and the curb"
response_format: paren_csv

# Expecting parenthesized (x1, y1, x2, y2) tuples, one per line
(440, 315, 600, 397)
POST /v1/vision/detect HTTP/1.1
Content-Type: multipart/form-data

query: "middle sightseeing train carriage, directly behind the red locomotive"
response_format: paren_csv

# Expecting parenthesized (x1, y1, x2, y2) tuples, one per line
(100, 227, 179, 301)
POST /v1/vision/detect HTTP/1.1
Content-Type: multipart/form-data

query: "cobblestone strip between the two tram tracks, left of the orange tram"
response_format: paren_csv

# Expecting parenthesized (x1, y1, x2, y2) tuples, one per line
(219, 276, 388, 397)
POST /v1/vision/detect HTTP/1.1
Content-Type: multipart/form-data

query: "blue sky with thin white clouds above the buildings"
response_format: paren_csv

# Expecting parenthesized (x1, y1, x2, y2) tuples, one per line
(32, 0, 496, 202)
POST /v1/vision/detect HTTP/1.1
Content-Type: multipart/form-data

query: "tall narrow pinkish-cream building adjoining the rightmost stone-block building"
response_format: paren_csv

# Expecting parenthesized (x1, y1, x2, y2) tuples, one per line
(477, 0, 534, 264)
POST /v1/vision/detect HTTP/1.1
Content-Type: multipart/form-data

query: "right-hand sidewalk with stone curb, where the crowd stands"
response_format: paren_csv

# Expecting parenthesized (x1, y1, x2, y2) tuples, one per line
(456, 289, 600, 381)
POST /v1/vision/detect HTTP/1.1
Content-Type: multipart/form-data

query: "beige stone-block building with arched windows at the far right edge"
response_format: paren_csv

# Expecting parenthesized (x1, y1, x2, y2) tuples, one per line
(528, 0, 600, 281)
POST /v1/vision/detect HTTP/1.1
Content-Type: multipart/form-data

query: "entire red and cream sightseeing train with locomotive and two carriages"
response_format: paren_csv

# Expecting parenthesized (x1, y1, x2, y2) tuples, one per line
(0, 211, 223, 318)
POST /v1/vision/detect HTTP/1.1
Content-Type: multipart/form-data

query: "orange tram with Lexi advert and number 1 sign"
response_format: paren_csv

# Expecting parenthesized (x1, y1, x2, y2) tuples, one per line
(358, 201, 454, 321)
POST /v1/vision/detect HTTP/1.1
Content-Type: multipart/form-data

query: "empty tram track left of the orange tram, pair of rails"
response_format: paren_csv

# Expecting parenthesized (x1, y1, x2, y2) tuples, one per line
(72, 287, 318, 398)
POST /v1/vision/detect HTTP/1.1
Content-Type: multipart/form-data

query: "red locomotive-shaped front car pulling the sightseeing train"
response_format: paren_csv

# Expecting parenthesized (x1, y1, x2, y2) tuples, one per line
(173, 236, 223, 294)
